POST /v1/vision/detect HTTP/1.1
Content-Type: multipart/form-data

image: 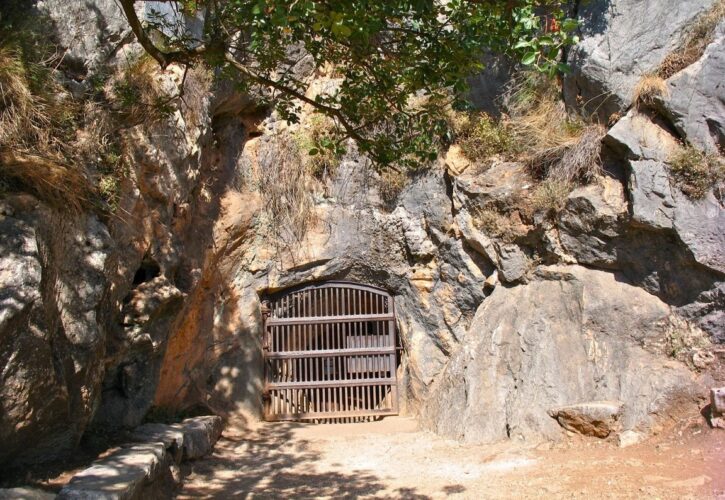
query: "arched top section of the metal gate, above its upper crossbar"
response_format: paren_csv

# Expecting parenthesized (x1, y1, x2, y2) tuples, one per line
(267, 281, 395, 320)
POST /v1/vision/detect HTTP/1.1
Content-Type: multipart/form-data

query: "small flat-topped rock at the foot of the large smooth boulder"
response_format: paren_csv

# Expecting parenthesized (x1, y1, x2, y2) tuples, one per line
(549, 401, 624, 438)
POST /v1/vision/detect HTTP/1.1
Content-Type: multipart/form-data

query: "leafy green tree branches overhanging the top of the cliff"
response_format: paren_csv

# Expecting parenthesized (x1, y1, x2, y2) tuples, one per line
(119, 0, 577, 167)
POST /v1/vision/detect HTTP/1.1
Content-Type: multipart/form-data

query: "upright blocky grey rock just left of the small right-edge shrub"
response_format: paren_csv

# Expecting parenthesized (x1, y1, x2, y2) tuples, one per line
(629, 160, 675, 229)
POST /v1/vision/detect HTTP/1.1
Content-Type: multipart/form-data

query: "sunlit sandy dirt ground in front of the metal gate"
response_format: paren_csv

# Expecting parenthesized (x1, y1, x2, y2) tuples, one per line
(179, 417, 725, 499)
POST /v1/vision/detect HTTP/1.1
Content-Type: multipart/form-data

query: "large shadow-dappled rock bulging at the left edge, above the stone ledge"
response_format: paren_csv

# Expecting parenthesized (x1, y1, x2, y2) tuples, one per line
(0, 201, 111, 465)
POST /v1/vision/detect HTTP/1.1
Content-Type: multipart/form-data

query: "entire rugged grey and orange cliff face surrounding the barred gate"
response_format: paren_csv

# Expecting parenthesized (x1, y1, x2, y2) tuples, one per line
(0, 0, 725, 470)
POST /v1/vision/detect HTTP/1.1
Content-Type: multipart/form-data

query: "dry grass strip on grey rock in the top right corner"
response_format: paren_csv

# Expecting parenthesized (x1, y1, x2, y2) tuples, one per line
(657, 0, 725, 80)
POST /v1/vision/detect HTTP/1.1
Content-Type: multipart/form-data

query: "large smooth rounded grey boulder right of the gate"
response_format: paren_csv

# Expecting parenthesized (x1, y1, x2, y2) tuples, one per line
(421, 266, 698, 442)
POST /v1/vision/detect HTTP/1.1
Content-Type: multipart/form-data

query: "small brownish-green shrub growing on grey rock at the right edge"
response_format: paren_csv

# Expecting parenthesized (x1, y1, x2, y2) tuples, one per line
(669, 145, 725, 199)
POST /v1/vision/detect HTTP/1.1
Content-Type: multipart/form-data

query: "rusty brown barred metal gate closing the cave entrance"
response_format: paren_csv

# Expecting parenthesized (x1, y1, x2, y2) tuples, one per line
(263, 282, 398, 421)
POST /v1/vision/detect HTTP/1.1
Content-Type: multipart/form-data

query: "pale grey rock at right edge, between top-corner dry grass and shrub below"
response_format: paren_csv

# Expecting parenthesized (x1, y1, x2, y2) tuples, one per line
(664, 27, 725, 152)
